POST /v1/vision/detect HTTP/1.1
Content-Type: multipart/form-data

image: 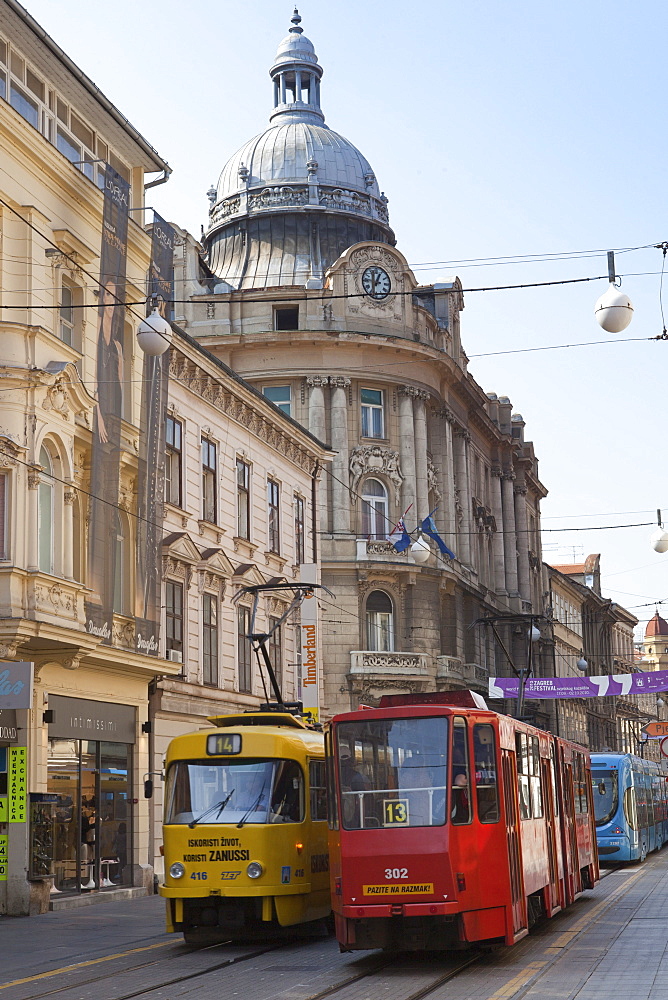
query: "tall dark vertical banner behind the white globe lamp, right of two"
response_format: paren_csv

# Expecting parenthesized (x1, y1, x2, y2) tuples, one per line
(135, 213, 176, 656)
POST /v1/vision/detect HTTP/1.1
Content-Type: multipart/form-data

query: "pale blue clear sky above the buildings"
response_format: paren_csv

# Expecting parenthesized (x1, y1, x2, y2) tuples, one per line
(23, 0, 668, 636)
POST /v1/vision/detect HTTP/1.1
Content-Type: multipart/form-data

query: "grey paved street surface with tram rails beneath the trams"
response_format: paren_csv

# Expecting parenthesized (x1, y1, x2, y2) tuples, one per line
(0, 850, 668, 1000)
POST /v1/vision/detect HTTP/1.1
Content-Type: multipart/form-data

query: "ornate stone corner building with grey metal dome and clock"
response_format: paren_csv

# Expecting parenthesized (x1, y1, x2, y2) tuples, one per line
(176, 10, 547, 724)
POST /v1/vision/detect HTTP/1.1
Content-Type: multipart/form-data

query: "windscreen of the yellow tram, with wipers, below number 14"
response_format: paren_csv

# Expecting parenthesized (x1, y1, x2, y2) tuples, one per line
(165, 758, 304, 826)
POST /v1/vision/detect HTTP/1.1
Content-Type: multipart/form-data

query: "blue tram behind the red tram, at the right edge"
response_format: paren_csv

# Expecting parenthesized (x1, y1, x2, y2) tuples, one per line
(591, 753, 668, 864)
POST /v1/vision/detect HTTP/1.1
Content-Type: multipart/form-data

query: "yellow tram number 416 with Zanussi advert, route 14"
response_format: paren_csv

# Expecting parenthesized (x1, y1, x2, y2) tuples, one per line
(160, 710, 331, 944)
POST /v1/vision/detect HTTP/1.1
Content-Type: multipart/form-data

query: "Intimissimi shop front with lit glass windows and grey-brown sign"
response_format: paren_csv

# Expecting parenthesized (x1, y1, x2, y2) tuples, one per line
(29, 694, 137, 894)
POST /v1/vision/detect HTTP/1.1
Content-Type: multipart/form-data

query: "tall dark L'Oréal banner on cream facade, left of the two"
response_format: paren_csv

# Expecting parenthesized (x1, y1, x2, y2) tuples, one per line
(86, 164, 131, 644)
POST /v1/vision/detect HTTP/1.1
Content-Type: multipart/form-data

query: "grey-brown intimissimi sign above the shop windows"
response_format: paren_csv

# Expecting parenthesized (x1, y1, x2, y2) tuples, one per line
(49, 694, 137, 743)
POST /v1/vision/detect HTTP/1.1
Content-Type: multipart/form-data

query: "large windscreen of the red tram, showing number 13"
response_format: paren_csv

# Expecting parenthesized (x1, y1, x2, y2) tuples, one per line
(336, 717, 448, 830)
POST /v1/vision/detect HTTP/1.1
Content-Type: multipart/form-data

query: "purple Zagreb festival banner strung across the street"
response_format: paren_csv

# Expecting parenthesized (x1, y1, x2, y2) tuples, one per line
(489, 670, 668, 699)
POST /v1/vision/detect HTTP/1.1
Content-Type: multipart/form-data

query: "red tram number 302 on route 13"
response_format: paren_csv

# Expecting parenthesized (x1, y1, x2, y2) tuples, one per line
(326, 691, 599, 951)
